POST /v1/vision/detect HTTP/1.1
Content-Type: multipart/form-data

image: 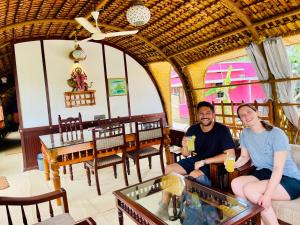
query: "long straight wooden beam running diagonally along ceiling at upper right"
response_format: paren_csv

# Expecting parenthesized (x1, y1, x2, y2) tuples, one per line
(168, 8, 300, 58)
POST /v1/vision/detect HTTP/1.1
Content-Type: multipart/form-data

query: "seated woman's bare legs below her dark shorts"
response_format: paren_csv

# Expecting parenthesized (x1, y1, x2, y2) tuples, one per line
(244, 180, 290, 225)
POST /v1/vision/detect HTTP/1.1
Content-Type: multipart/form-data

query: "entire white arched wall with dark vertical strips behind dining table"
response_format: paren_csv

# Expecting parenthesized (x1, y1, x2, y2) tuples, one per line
(15, 40, 163, 128)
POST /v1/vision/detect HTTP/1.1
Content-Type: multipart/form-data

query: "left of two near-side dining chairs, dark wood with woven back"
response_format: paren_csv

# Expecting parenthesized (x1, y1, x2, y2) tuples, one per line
(85, 124, 128, 195)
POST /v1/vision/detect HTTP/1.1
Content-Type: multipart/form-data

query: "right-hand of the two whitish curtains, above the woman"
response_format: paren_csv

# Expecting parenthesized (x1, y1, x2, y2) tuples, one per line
(263, 37, 299, 127)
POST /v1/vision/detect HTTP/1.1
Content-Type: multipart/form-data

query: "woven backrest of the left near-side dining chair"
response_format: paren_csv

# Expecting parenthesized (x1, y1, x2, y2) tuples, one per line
(92, 124, 126, 160)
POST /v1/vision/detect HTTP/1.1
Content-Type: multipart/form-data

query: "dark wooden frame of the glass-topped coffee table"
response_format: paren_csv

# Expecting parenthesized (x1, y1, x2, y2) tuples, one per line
(114, 177, 263, 225)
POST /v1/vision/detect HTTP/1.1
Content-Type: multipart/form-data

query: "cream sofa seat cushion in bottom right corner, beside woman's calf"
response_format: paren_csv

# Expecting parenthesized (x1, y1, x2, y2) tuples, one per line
(272, 198, 300, 225)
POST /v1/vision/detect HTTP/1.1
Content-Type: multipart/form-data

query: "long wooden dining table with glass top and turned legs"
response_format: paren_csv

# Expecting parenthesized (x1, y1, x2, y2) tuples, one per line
(39, 126, 171, 205)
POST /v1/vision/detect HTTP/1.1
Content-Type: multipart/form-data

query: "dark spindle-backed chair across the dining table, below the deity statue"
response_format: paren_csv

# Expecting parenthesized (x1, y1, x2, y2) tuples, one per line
(58, 113, 83, 180)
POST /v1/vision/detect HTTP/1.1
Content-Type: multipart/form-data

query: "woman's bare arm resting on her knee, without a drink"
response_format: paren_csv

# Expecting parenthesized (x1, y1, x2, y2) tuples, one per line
(258, 150, 288, 208)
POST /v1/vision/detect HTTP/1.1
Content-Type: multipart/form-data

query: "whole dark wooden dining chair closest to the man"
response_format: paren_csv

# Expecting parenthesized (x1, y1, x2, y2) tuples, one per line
(126, 119, 165, 182)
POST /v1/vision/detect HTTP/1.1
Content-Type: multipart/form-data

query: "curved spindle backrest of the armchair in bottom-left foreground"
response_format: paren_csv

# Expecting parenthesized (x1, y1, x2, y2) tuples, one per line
(0, 188, 69, 225)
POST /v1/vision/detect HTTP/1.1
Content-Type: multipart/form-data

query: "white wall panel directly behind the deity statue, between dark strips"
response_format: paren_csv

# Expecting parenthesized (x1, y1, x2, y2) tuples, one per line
(44, 40, 108, 124)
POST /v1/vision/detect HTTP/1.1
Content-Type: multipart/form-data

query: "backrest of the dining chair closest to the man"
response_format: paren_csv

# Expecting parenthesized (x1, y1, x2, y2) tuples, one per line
(135, 118, 163, 149)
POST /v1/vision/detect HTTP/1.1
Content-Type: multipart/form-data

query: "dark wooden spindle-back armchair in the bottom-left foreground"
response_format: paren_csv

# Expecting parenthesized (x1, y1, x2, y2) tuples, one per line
(0, 188, 96, 225)
